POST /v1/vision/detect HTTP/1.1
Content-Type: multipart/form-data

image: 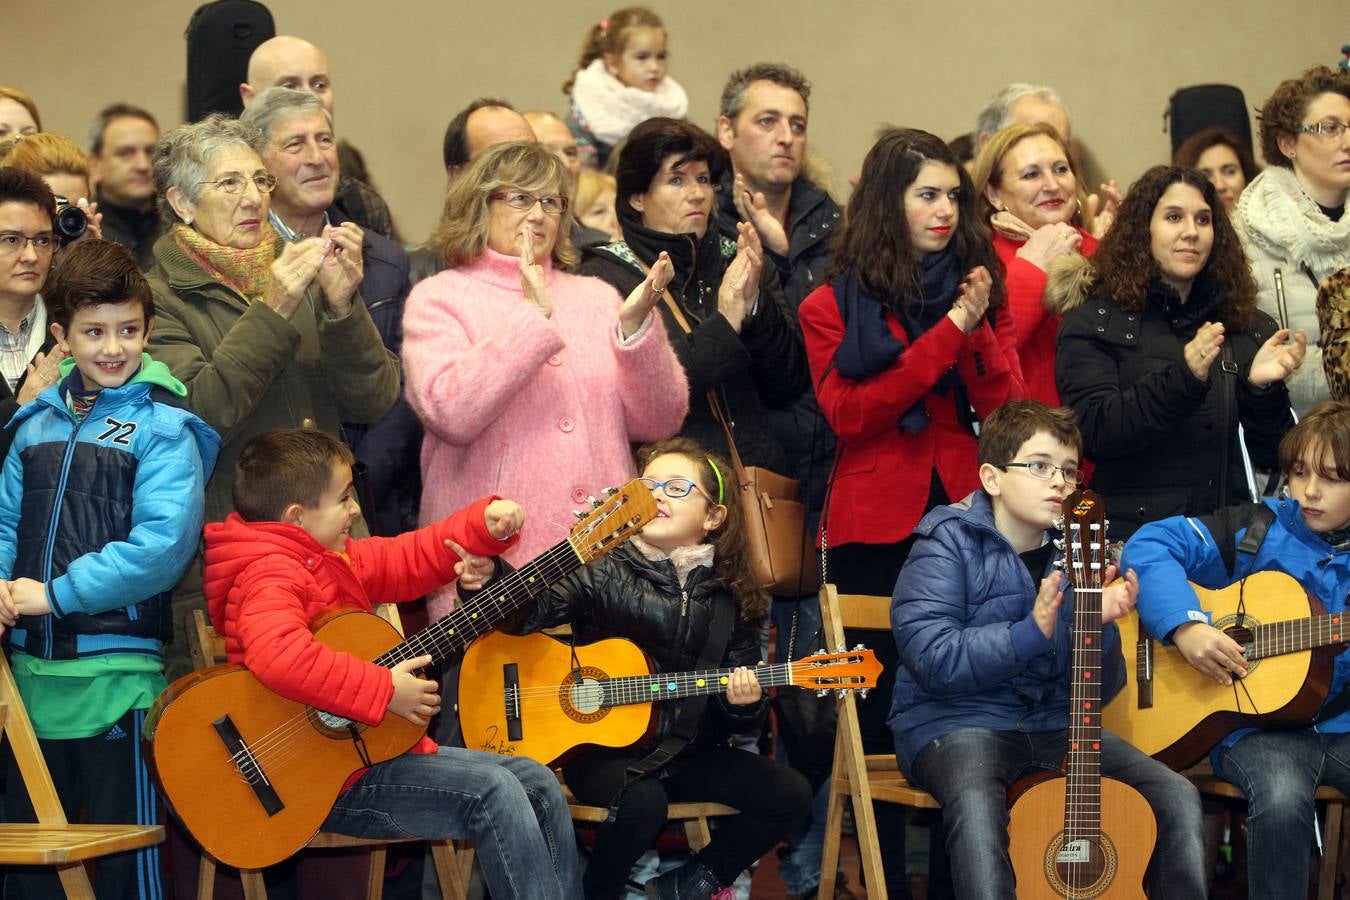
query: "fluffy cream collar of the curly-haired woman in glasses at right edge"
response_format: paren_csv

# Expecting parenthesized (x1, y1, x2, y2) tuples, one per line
(1238, 166, 1350, 282)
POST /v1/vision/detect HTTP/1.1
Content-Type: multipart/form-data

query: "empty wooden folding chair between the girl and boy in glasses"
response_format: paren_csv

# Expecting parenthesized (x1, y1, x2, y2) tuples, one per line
(817, 584, 938, 900)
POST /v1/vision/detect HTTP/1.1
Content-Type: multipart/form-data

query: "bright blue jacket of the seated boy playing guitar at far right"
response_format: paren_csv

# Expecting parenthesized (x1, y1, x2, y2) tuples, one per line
(1122, 499, 1350, 770)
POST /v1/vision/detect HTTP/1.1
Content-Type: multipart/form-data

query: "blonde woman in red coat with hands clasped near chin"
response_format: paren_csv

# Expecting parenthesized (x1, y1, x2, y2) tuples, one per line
(971, 124, 1096, 406)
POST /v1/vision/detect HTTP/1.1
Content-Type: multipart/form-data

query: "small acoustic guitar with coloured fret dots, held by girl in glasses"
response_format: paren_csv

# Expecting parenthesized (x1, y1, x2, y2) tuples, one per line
(459, 631, 882, 765)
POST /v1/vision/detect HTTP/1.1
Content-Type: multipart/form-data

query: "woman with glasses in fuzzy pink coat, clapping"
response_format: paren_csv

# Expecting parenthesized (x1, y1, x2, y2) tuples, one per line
(402, 143, 689, 615)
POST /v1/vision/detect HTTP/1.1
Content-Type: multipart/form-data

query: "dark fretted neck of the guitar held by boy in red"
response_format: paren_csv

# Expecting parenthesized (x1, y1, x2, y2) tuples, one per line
(374, 540, 585, 668)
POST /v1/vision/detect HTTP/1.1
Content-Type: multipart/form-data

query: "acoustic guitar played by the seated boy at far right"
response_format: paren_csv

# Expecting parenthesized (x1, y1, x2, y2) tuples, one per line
(1104, 572, 1345, 770)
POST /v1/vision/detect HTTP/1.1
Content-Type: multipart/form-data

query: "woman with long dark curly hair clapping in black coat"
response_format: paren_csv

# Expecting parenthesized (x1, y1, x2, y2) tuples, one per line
(1048, 166, 1307, 540)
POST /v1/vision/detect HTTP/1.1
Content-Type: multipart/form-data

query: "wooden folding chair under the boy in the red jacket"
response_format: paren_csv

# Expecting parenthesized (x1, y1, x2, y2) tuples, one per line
(188, 603, 474, 900)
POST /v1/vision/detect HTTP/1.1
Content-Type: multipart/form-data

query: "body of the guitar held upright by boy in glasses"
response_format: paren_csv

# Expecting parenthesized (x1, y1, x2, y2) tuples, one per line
(1008, 772, 1158, 900)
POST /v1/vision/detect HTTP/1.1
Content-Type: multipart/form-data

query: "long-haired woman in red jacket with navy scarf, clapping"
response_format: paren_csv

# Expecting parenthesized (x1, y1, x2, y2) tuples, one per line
(798, 128, 1022, 896)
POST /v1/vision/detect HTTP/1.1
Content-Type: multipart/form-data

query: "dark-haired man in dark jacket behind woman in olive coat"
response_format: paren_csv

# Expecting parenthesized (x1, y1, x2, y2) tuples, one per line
(89, 103, 163, 271)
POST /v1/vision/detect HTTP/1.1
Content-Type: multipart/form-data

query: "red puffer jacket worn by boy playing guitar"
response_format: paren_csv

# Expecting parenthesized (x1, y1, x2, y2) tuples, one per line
(203, 498, 518, 734)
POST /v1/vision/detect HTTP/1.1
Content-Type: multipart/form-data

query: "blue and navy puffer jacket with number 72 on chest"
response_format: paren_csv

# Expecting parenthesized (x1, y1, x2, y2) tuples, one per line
(0, 355, 220, 660)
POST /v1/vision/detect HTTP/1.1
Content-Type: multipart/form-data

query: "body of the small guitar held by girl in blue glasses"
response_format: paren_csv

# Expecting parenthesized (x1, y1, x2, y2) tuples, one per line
(459, 631, 655, 765)
